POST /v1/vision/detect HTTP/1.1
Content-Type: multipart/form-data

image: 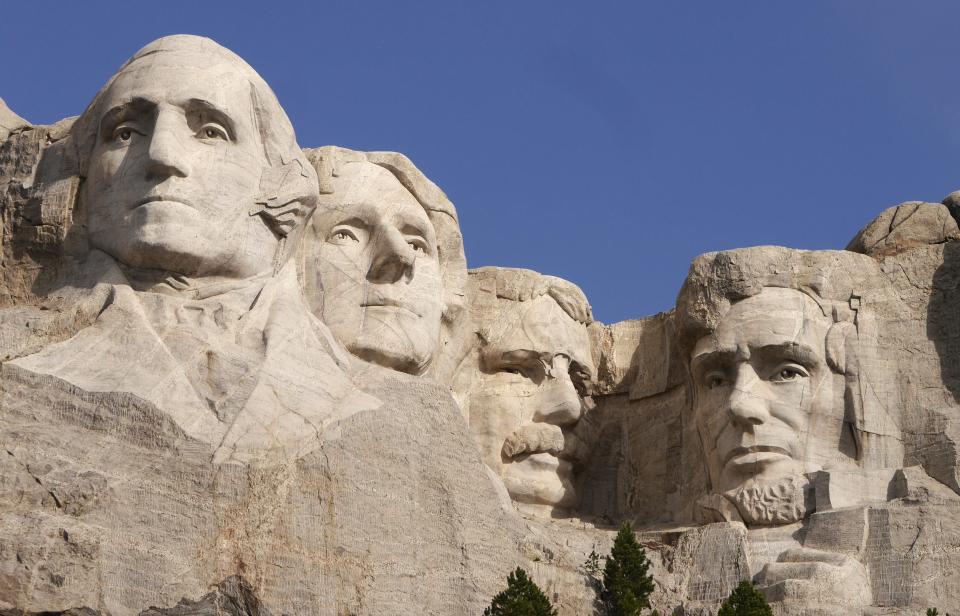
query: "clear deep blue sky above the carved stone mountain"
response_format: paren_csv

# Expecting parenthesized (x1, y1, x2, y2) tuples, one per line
(0, 0, 960, 322)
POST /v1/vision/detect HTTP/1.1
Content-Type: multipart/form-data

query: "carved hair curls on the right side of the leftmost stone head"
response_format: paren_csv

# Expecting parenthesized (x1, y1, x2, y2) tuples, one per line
(250, 158, 317, 237)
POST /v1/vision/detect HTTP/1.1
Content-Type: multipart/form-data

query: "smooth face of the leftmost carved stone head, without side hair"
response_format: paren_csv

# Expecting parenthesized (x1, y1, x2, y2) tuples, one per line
(82, 51, 278, 278)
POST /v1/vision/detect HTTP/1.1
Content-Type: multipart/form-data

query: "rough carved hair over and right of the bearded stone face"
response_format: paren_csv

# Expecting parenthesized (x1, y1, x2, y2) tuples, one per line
(674, 246, 903, 468)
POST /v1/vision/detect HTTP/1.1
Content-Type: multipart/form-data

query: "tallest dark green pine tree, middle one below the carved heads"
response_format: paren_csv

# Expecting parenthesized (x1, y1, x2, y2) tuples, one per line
(600, 522, 653, 616)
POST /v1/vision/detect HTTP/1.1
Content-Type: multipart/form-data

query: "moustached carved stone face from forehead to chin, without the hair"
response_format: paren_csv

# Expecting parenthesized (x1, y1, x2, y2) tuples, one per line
(469, 296, 592, 508)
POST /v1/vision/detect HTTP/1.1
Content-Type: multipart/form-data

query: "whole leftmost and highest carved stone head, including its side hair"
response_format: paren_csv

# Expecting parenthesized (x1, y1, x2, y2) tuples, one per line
(73, 35, 317, 278)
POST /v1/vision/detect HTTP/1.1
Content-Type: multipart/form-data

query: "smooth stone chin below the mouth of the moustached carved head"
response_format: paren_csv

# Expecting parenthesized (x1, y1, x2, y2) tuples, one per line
(502, 453, 577, 509)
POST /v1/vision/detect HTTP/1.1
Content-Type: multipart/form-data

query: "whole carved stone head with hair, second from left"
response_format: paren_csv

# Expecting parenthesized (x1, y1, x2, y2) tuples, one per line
(302, 147, 466, 375)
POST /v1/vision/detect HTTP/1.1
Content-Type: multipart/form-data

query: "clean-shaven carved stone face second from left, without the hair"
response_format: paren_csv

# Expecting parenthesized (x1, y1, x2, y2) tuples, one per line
(307, 162, 443, 374)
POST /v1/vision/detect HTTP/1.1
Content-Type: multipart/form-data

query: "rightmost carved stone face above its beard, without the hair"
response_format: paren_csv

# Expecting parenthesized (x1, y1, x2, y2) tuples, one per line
(691, 288, 855, 492)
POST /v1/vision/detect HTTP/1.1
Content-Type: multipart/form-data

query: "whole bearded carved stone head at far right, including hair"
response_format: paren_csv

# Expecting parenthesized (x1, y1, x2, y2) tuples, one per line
(676, 247, 902, 523)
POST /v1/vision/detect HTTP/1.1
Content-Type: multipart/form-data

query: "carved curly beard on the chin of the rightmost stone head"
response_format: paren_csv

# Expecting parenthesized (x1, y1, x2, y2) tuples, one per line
(723, 475, 813, 526)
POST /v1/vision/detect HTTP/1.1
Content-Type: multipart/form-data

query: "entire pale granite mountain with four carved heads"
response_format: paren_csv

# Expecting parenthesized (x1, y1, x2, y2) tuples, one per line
(0, 35, 960, 616)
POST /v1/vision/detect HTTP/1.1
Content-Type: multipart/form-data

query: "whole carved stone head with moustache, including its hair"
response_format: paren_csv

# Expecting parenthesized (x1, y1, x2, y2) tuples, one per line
(465, 267, 593, 513)
